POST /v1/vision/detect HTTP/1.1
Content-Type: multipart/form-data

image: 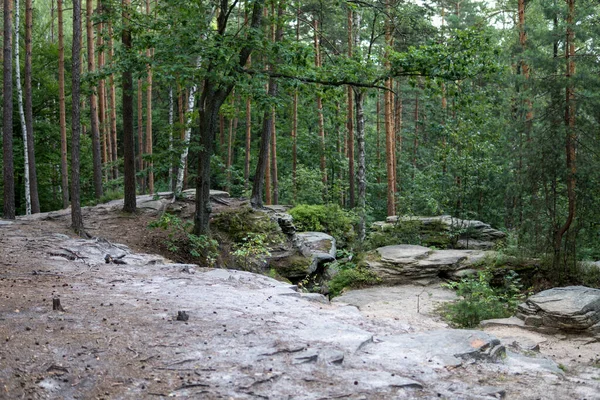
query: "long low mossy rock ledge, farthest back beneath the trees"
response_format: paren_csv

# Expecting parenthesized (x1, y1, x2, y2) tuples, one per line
(370, 215, 506, 250)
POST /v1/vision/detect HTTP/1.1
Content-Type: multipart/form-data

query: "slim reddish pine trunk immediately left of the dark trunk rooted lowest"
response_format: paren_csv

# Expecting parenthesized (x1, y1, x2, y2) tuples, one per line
(57, 0, 69, 208)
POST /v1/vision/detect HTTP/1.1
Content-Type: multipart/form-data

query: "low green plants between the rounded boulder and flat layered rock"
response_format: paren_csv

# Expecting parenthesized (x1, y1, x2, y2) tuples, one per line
(328, 250, 380, 298)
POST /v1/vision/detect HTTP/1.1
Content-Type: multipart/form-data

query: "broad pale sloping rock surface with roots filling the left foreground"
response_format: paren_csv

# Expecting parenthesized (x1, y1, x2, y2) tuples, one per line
(0, 206, 600, 399)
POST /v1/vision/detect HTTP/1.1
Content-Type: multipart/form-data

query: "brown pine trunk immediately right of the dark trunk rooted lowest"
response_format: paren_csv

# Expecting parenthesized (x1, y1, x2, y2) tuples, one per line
(86, 0, 102, 199)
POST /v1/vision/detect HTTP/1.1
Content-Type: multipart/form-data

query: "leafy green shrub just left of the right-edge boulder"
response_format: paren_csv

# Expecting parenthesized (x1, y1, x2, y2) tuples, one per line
(440, 270, 524, 328)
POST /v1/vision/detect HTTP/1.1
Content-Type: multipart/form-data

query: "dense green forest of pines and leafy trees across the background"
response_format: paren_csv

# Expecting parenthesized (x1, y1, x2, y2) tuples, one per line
(0, 0, 600, 278)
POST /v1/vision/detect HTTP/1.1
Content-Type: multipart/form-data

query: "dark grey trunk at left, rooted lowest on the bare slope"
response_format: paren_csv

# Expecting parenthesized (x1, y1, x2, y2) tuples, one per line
(71, 0, 85, 231)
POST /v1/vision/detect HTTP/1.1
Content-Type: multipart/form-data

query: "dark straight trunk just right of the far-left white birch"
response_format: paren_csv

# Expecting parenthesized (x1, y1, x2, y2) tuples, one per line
(25, 0, 40, 214)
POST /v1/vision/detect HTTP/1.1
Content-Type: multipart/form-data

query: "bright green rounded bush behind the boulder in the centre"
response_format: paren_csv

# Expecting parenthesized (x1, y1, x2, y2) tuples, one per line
(290, 204, 357, 248)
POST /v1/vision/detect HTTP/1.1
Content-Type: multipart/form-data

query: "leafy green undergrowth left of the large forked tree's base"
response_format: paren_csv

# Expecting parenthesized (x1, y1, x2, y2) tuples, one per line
(148, 213, 219, 267)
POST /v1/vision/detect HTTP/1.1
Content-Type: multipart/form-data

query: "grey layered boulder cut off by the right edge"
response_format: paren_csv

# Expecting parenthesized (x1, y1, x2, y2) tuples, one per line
(517, 286, 600, 334)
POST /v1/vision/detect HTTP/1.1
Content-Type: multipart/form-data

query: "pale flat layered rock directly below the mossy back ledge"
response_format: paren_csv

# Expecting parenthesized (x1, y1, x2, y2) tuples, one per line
(365, 245, 485, 285)
